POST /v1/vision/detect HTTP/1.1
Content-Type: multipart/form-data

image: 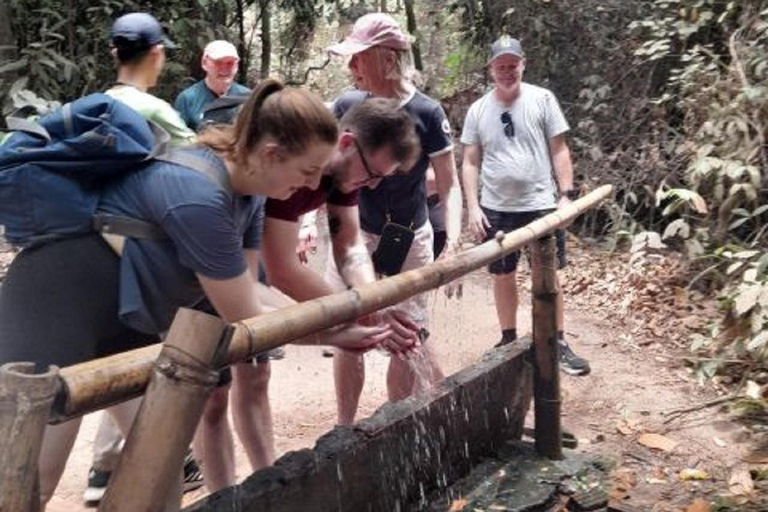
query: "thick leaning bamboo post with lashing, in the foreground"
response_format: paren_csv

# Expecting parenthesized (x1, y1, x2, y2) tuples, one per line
(99, 309, 232, 512)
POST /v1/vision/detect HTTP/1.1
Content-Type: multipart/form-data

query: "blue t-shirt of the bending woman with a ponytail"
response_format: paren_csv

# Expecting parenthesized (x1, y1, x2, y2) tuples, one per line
(99, 148, 265, 334)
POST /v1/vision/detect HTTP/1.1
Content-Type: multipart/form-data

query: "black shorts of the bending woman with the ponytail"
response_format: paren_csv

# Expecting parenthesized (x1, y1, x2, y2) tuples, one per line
(0, 234, 160, 367)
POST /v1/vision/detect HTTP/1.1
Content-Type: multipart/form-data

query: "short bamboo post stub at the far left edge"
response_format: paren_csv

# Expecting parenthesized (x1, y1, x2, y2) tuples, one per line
(0, 363, 59, 512)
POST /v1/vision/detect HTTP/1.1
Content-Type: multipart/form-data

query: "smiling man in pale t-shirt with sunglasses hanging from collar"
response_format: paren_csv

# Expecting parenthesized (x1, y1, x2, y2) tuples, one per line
(461, 35, 590, 375)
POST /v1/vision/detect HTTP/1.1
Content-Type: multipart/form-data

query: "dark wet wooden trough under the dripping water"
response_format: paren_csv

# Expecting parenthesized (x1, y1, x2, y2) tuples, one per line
(185, 338, 533, 512)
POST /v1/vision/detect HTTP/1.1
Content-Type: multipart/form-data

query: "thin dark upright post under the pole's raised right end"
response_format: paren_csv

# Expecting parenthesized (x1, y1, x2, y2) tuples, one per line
(530, 234, 563, 460)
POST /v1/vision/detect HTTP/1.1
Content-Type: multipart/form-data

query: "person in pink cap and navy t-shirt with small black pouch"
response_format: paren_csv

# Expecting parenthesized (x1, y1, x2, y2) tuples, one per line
(328, 13, 462, 425)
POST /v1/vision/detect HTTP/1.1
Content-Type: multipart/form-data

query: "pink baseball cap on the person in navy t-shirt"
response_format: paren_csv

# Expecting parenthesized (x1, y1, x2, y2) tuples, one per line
(328, 12, 411, 55)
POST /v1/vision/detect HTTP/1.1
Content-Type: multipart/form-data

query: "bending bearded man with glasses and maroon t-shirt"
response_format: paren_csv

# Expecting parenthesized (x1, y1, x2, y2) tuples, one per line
(262, 98, 420, 364)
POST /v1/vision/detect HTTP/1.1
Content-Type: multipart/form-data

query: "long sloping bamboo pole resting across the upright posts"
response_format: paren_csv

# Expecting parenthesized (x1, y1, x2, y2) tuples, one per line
(51, 185, 613, 423)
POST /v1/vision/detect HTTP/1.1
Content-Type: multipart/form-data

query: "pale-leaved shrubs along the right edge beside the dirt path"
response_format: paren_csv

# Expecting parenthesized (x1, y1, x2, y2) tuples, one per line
(630, 0, 768, 376)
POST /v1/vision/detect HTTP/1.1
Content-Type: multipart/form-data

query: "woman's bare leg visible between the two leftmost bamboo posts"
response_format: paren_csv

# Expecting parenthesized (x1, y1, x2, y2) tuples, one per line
(38, 418, 82, 504)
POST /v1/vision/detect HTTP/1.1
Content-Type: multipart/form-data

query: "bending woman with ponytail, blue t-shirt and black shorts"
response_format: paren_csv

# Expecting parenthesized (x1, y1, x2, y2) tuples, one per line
(0, 80, 400, 504)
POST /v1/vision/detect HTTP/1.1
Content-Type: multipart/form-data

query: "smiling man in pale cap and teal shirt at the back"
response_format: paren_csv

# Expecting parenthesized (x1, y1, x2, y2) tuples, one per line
(173, 40, 251, 131)
